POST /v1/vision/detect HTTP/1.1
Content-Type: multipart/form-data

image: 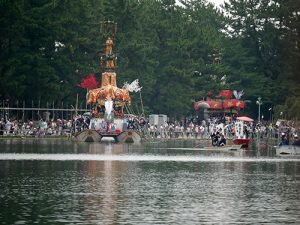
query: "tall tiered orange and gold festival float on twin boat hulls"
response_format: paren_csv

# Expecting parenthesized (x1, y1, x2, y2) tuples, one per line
(75, 21, 141, 143)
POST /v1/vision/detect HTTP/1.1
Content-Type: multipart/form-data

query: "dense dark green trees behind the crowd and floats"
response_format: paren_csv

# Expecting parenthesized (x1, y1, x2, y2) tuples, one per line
(0, 0, 300, 118)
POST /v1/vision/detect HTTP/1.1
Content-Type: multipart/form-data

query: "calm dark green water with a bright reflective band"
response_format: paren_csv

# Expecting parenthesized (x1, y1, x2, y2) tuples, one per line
(0, 139, 300, 224)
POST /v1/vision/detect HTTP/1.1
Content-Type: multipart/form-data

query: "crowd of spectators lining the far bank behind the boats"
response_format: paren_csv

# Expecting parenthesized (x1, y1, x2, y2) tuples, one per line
(0, 115, 299, 145)
